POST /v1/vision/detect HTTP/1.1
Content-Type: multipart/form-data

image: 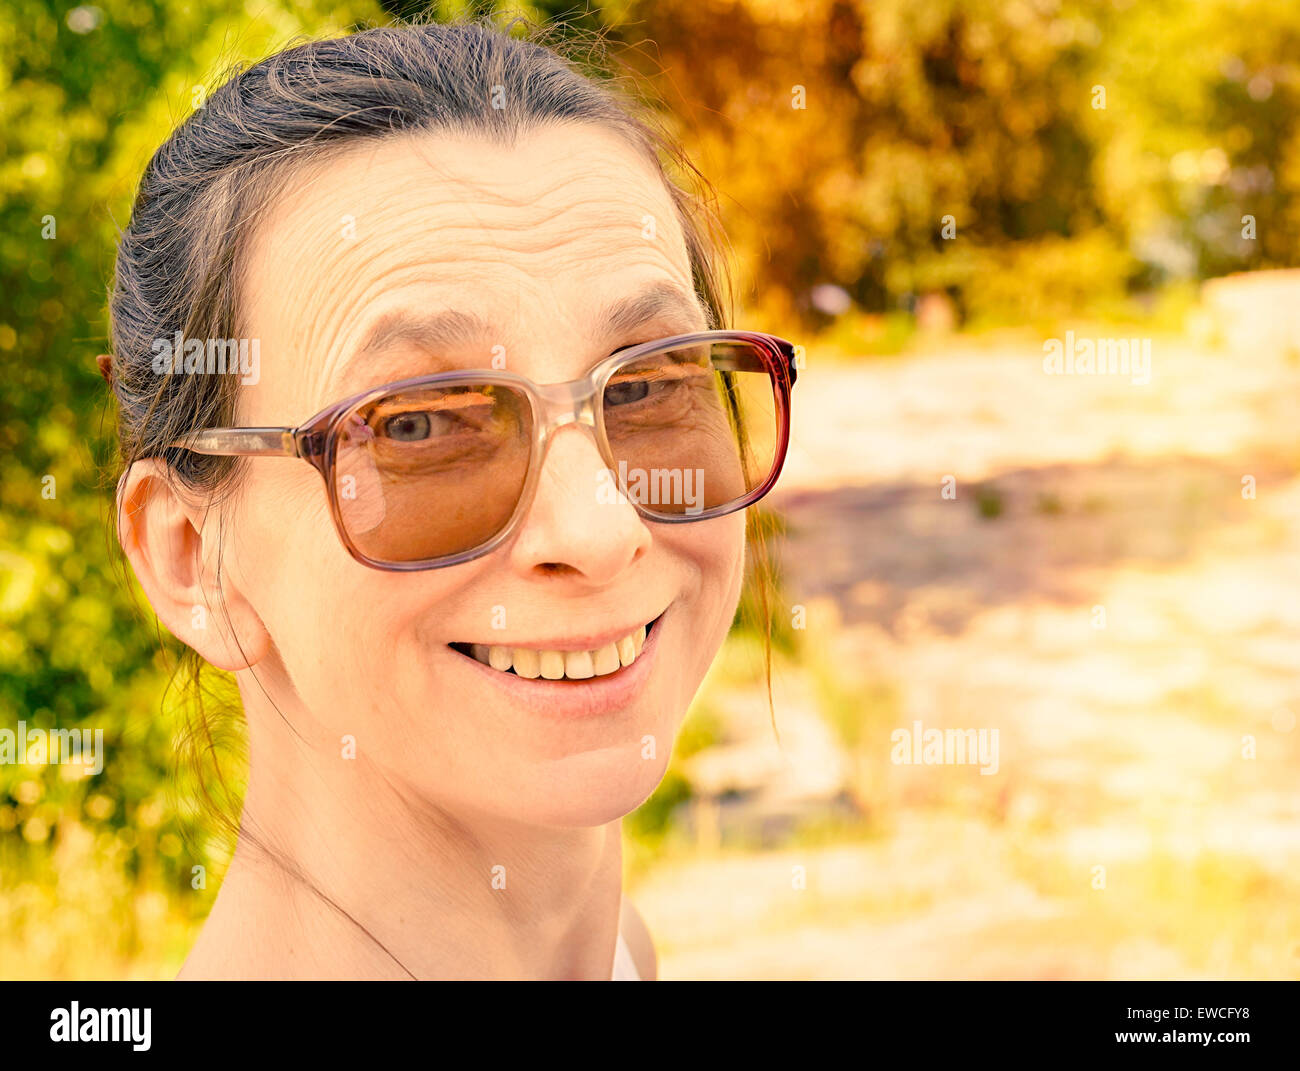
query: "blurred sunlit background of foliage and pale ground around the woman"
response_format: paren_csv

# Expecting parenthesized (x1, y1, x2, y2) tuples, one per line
(0, 0, 1300, 979)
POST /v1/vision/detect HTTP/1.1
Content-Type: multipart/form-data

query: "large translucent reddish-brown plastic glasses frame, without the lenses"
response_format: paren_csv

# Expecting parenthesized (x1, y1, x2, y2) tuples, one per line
(168, 331, 797, 572)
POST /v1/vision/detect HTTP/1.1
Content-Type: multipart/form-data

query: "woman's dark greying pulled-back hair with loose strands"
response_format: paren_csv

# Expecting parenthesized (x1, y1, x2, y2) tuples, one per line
(101, 10, 775, 977)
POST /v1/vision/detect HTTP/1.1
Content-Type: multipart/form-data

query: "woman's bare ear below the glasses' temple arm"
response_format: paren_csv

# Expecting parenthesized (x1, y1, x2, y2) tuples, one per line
(117, 459, 270, 672)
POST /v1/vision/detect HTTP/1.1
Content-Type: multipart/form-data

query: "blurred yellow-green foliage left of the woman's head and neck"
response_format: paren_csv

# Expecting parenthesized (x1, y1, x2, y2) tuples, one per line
(0, 0, 378, 970)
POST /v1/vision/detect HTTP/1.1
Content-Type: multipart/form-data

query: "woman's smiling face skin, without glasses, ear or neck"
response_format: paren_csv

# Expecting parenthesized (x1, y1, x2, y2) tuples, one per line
(213, 125, 744, 825)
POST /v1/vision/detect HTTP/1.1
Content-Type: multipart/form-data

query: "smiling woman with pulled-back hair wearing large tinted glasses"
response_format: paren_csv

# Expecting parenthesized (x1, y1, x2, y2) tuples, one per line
(104, 23, 794, 979)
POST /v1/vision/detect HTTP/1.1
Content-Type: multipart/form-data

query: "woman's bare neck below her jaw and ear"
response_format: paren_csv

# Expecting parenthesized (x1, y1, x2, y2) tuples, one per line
(181, 675, 623, 979)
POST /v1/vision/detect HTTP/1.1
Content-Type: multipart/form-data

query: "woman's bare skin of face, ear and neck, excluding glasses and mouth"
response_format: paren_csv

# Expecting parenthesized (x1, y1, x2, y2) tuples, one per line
(121, 125, 744, 979)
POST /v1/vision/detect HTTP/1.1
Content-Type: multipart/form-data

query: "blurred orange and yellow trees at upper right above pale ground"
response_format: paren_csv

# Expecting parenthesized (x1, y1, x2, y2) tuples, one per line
(621, 0, 1300, 325)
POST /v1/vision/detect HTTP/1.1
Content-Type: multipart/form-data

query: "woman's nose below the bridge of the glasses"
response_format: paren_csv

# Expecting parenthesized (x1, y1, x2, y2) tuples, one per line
(510, 422, 651, 587)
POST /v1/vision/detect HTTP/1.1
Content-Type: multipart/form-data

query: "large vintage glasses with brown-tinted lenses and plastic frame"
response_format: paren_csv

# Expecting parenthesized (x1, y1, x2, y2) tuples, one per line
(169, 331, 796, 571)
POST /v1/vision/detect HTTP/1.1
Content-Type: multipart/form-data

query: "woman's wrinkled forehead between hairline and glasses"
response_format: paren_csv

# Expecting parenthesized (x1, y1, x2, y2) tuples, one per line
(233, 125, 699, 413)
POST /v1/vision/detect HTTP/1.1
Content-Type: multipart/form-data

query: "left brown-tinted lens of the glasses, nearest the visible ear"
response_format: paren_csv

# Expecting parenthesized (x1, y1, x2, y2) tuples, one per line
(334, 383, 533, 563)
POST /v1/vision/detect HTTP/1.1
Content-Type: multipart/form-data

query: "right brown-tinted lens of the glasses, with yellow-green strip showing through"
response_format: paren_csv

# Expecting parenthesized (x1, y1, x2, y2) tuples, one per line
(603, 342, 780, 515)
